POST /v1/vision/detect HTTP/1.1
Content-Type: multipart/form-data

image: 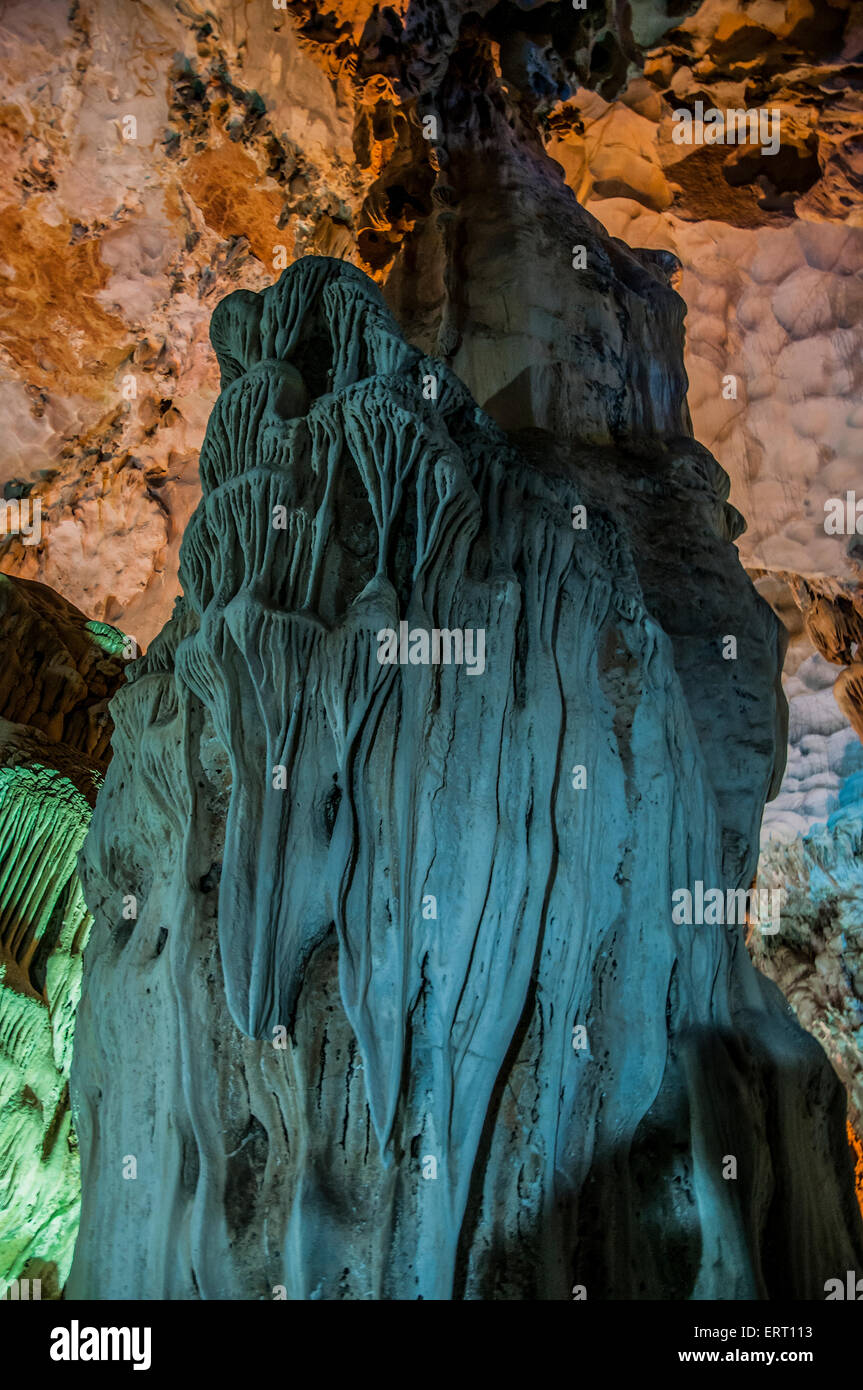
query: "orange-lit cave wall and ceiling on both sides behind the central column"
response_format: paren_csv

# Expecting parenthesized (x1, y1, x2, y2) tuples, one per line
(0, 0, 863, 656)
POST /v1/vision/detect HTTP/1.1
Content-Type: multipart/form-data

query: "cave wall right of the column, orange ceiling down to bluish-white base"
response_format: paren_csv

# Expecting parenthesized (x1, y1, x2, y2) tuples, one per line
(536, 0, 863, 1150)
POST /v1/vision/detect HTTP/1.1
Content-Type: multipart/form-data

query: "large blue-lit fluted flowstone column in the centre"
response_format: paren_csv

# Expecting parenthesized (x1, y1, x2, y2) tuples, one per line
(68, 258, 863, 1300)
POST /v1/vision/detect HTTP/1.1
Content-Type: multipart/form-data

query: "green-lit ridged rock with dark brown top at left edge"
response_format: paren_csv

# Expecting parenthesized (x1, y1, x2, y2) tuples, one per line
(0, 577, 124, 1298)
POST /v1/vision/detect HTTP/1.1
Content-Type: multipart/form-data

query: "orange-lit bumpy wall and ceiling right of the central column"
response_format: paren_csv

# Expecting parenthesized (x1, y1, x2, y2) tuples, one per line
(545, 0, 863, 733)
